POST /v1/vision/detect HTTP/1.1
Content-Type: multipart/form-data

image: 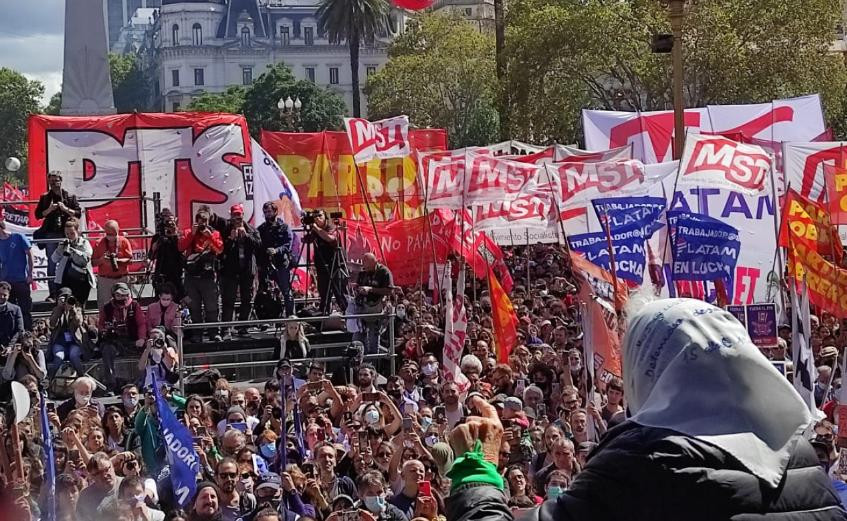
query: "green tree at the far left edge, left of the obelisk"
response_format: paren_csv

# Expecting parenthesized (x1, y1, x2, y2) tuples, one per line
(0, 67, 44, 173)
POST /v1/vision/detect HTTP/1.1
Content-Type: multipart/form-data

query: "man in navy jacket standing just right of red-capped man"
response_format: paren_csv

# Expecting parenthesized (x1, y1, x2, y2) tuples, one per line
(257, 201, 294, 317)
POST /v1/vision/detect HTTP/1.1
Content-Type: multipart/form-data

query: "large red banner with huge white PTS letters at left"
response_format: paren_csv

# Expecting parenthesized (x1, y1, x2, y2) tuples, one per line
(28, 112, 253, 233)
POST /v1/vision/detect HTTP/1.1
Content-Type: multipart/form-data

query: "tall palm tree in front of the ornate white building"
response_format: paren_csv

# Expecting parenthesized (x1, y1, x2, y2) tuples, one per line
(317, 0, 389, 118)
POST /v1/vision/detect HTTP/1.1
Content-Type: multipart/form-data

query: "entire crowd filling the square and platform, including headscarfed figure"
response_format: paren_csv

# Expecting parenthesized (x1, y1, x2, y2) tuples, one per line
(0, 169, 847, 521)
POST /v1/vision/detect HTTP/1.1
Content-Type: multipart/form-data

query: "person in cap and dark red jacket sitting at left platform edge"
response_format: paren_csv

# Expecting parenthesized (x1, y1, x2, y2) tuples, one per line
(99, 282, 147, 392)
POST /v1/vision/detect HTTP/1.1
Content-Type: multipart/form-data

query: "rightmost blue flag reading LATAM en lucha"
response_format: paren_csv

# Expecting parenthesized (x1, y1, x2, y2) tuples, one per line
(668, 211, 741, 288)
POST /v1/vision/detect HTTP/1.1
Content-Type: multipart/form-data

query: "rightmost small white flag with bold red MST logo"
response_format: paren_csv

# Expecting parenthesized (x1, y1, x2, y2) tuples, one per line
(684, 138, 771, 190)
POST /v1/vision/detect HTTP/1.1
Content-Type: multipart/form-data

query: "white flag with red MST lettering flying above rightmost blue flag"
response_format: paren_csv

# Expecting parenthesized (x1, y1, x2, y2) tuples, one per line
(678, 134, 771, 195)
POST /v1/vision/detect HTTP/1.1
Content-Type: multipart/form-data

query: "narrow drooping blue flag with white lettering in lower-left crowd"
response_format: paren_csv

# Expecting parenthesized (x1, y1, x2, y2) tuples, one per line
(153, 375, 200, 508)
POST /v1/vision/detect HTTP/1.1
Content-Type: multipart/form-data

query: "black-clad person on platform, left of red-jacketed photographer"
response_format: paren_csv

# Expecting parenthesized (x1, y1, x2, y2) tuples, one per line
(147, 208, 185, 300)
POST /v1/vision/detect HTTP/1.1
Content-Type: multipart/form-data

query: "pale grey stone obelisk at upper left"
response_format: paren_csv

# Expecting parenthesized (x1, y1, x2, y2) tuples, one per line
(60, 0, 115, 116)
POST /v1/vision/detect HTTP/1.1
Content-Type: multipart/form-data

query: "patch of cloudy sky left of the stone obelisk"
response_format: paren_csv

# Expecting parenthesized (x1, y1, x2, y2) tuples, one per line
(0, 0, 66, 105)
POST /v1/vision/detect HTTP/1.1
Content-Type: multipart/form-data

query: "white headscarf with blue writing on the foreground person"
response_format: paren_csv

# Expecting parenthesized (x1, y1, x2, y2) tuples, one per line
(623, 299, 812, 488)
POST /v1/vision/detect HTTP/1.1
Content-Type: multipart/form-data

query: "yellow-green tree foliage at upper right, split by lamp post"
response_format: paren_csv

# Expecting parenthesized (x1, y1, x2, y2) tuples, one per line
(506, 0, 847, 142)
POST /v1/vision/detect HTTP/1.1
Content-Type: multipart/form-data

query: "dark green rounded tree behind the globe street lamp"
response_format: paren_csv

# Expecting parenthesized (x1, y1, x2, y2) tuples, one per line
(240, 63, 346, 137)
